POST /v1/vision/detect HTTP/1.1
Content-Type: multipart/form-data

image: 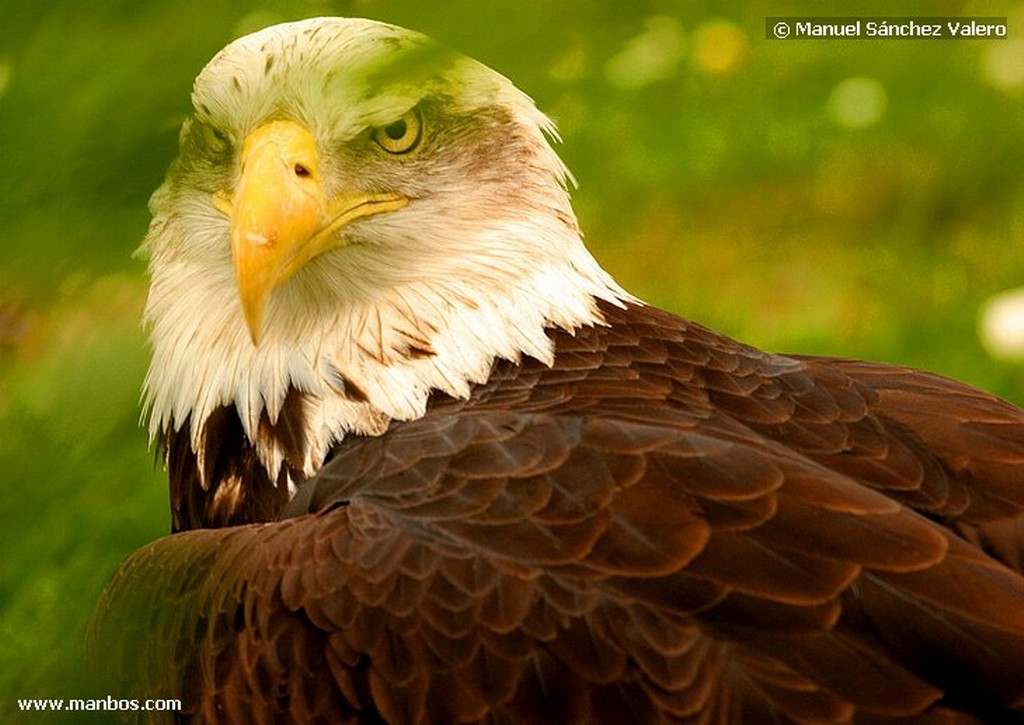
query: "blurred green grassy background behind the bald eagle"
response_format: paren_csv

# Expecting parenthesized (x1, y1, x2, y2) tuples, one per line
(0, 0, 1024, 722)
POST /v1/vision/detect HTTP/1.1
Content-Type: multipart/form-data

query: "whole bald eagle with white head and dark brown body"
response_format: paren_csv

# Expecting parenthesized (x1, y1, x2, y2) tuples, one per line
(94, 18, 1024, 723)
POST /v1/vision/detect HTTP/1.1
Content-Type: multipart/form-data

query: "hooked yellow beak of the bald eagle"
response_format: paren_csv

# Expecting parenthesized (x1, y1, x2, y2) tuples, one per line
(213, 121, 409, 345)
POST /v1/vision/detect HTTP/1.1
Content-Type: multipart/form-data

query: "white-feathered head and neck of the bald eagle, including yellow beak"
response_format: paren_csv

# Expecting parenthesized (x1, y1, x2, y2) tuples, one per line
(143, 18, 628, 503)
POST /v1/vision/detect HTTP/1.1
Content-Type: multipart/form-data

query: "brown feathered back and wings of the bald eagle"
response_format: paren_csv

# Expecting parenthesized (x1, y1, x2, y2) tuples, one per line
(96, 307, 1024, 722)
